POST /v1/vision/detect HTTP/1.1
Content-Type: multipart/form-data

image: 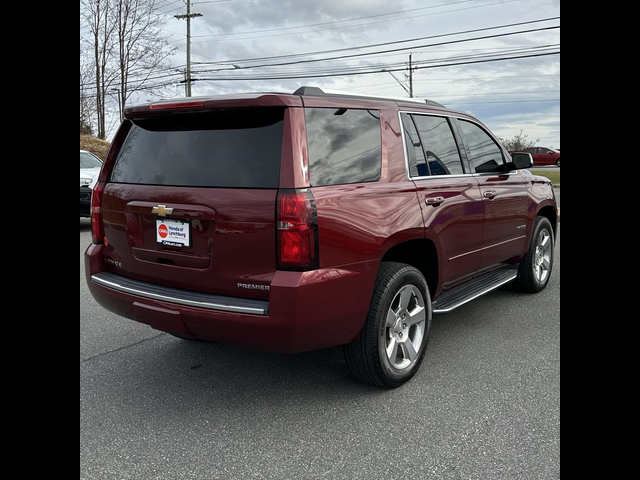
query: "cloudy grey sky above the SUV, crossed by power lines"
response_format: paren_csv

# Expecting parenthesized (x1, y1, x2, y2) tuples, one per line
(92, 0, 560, 148)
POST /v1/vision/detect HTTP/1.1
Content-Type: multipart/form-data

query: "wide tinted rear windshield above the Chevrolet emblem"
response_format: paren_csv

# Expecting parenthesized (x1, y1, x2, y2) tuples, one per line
(111, 108, 284, 188)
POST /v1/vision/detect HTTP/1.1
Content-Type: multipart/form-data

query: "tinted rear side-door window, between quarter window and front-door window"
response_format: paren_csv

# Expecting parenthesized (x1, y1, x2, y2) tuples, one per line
(412, 115, 464, 175)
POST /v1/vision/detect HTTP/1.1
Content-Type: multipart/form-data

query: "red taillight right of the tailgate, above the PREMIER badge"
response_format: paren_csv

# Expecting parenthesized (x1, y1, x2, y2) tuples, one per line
(276, 189, 318, 270)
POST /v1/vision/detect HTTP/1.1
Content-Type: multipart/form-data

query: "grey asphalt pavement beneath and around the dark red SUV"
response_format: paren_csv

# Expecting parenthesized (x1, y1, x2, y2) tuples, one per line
(80, 219, 560, 480)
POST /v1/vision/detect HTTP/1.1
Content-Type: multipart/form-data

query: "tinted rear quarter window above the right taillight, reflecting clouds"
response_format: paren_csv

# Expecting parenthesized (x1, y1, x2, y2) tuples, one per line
(305, 108, 382, 186)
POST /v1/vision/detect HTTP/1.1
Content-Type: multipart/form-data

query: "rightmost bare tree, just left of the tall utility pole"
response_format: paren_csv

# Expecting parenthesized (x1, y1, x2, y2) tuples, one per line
(113, 0, 176, 119)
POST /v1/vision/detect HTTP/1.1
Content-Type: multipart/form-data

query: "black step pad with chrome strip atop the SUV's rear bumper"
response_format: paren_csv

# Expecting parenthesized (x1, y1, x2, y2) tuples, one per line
(91, 272, 269, 315)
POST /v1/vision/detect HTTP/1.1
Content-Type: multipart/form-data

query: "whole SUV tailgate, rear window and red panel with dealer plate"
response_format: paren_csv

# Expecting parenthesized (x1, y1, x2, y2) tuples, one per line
(102, 107, 284, 298)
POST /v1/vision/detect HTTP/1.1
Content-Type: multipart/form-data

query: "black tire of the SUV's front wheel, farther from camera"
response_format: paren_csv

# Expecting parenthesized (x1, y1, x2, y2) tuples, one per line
(516, 216, 555, 293)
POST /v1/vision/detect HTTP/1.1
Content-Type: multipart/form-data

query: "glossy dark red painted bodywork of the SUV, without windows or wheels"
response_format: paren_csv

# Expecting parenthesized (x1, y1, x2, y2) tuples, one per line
(85, 94, 556, 352)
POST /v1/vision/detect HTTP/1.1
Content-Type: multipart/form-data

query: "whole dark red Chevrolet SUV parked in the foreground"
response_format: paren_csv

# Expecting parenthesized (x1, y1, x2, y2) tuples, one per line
(85, 87, 557, 387)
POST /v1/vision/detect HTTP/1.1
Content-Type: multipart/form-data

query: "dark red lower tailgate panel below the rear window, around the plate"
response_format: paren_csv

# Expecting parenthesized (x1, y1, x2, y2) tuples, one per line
(102, 183, 278, 299)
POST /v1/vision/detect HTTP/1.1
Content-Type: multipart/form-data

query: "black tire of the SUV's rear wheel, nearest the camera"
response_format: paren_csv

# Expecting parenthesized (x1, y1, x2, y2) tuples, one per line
(344, 262, 432, 388)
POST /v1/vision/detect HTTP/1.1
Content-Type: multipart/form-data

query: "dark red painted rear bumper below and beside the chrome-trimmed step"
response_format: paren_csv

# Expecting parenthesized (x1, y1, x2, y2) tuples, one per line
(85, 245, 377, 353)
